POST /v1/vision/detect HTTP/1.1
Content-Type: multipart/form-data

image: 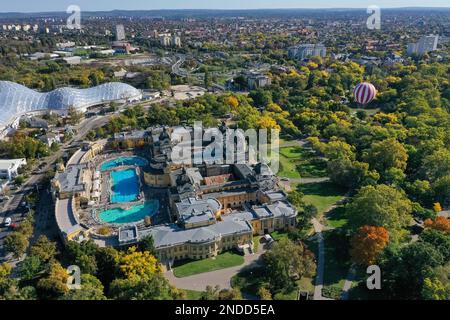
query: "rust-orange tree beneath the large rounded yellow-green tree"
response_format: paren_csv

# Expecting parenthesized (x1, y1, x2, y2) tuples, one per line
(350, 226, 389, 266)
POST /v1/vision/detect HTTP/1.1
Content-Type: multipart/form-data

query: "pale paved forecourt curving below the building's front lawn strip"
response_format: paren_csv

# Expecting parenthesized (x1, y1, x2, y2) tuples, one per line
(164, 249, 263, 291)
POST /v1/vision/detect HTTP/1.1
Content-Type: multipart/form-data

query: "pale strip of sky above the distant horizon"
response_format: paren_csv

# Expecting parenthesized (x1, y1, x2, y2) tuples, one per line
(0, 0, 450, 12)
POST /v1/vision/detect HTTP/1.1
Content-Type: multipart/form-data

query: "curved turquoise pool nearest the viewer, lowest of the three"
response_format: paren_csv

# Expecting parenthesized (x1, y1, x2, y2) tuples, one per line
(99, 200, 159, 224)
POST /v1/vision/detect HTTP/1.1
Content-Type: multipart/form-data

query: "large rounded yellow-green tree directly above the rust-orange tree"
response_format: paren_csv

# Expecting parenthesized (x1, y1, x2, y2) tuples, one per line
(346, 184, 412, 236)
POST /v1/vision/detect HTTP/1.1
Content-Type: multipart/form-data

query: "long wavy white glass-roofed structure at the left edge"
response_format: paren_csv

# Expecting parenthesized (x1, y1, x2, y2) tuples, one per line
(0, 81, 142, 126)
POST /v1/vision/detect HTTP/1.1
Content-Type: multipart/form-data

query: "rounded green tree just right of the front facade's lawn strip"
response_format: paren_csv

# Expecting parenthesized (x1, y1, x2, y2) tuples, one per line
(263, 239, 316, 291)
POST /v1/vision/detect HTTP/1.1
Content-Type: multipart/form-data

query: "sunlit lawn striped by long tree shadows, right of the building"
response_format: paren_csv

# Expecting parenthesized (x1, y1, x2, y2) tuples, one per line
(278, 147, 327, 179)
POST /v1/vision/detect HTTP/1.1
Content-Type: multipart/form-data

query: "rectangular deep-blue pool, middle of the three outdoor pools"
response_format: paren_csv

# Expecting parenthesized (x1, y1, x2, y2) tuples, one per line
(111, 169, 139, 203)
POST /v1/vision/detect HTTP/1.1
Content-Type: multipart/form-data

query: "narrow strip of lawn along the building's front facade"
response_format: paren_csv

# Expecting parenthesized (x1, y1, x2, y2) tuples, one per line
(173, 252, 244, 278)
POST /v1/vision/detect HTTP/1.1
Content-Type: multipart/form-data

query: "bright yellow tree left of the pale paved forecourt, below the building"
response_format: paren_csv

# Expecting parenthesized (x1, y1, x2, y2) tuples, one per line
(119, 247, 162, 279)
